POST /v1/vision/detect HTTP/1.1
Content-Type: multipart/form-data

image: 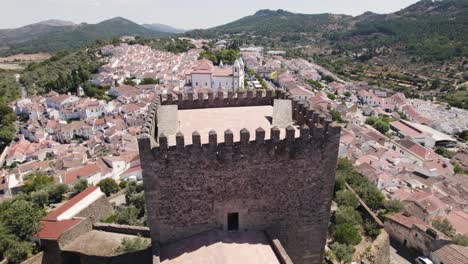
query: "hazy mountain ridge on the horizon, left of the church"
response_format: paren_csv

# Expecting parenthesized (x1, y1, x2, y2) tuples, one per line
(0, 17, 170, 56)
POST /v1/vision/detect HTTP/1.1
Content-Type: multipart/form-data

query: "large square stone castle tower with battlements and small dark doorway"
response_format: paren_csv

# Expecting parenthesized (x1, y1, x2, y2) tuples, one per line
(138, 91, 340, 264)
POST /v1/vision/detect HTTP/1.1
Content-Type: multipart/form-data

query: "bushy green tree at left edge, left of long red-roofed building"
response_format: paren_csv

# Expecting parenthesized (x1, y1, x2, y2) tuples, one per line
(2, 200, 45, 240)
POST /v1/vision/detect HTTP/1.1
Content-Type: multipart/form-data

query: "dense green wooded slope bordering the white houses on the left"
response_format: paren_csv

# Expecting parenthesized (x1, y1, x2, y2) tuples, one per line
(21, 49, 103, 94)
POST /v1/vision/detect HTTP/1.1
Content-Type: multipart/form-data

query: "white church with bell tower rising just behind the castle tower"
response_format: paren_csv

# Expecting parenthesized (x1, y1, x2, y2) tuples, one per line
(185, 59, 245, 91)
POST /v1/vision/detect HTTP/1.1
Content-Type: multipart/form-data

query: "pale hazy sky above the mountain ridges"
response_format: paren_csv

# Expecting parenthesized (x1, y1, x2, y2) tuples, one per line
(0, 0, 417, 29)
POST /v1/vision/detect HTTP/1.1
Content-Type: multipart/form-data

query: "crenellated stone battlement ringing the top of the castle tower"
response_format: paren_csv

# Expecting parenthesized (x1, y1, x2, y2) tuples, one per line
(142, 91, 340, 154)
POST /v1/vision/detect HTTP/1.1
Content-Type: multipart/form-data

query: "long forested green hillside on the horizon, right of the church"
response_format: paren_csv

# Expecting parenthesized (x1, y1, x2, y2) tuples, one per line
(187, 0, 468, 60)
